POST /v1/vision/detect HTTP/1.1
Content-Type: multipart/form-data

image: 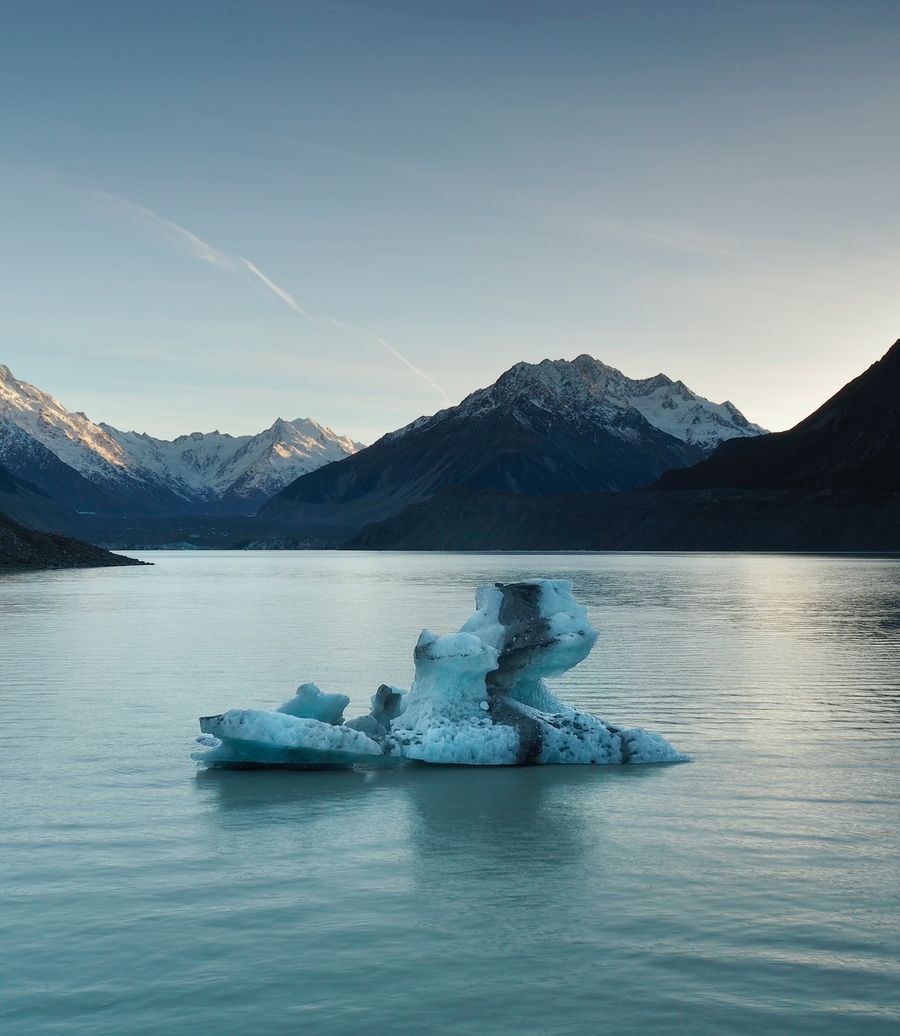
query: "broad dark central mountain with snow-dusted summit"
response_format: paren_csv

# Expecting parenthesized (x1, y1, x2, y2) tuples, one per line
(261, 355, 763, 530)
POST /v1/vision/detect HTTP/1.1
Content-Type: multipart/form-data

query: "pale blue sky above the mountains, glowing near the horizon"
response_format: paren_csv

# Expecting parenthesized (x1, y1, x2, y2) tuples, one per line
(0, 0, 900, 441)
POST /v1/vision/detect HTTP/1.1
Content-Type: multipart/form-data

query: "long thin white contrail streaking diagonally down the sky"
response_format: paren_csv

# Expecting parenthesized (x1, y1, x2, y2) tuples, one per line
(90, 191, 451, 404)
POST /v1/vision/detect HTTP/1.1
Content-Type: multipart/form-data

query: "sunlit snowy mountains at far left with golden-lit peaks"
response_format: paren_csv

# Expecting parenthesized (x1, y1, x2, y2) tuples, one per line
(0, 365, 361, 515)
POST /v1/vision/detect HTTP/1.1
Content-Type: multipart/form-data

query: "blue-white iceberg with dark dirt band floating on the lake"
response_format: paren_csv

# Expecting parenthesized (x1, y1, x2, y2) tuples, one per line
(194, 579, 686, 769)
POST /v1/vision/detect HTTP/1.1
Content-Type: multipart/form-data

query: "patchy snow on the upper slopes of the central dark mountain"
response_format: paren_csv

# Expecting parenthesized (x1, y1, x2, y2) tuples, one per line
(428, 354, 765, 450)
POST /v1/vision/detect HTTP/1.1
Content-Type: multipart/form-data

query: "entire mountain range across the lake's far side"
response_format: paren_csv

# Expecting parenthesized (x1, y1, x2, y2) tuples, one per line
(0, 342, 900, 563)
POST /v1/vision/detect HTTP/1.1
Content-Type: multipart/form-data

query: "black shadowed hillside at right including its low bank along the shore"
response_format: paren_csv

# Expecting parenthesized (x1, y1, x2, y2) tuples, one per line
(352, 341, 900, 551)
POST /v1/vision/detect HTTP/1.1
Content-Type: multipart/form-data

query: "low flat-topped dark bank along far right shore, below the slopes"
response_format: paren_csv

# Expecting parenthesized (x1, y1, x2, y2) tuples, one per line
(347, 490, 900, 551)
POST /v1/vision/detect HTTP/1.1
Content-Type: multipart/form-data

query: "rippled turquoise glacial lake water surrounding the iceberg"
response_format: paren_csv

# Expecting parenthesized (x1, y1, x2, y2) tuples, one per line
(0, 551, 900, 1036)
